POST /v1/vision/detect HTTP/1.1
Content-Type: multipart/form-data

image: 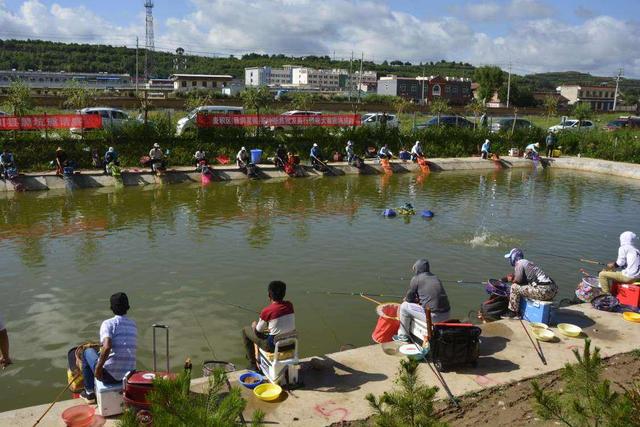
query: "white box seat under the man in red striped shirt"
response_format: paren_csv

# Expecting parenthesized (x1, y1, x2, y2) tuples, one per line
(257, 332, 300, 385)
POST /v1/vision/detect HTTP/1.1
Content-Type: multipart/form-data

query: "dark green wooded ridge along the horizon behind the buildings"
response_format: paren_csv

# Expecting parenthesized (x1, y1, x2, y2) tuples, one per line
(0, 40, 640, 91)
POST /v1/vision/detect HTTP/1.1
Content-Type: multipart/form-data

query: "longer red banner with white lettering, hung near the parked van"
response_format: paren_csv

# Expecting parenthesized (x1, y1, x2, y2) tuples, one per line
(196, 113, 361, 128)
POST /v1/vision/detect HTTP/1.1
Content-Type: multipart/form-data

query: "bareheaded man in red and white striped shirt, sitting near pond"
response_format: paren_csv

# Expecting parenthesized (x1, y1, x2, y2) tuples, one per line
(242, 280, 296, 370)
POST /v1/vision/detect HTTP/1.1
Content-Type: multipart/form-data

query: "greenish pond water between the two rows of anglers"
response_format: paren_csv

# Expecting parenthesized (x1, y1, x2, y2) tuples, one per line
(0, 170, 640, 410)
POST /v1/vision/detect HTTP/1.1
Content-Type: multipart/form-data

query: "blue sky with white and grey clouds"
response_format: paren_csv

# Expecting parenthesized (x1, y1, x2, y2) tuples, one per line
(0, 0, 640, 78)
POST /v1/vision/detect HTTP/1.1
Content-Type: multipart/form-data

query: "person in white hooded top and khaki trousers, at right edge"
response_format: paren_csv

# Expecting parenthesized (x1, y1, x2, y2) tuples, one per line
(598, 231, 640, 293)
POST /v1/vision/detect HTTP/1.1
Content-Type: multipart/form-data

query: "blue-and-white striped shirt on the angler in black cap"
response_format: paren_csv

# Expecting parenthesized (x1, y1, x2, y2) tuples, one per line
(100, 316, 138, 381)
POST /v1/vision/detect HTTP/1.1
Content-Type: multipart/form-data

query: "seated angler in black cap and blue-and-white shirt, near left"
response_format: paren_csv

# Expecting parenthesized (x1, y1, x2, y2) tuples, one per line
(80, 292, 138, 403)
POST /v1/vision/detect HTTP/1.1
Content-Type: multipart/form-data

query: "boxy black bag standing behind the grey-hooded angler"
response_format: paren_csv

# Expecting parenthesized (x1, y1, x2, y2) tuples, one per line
(429, 323, 482, 372)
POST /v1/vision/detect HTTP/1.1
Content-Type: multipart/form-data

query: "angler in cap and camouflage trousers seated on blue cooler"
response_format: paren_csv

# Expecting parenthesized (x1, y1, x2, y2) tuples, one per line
(502, 248, 558, 319)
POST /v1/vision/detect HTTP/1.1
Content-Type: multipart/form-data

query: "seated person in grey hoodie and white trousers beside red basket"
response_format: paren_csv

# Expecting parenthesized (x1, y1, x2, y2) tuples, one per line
(393, 258, 451, 342)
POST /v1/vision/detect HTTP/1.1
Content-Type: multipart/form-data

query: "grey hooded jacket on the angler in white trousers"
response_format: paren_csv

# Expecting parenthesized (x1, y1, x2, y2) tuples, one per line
(404, 259, 451, 313)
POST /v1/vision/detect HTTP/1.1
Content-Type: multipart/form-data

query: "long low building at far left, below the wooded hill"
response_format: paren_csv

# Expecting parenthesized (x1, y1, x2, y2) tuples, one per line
(0, 70, 134, 90)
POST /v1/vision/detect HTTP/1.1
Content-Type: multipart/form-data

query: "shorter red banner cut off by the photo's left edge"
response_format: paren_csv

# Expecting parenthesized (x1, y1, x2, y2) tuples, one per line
(0, 114, 102, 131)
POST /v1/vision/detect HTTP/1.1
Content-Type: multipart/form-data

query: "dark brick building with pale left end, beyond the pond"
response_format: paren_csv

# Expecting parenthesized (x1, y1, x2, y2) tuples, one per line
(377, 76, 471, 105)
